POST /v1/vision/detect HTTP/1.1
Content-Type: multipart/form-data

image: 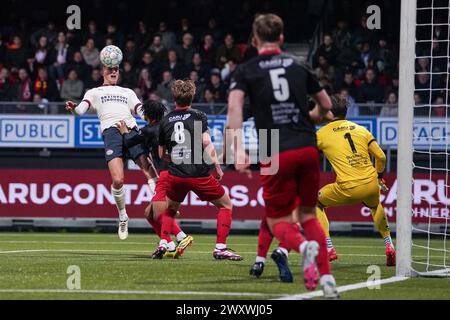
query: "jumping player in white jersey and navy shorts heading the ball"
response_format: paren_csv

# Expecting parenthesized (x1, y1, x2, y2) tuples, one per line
(66, 66, 157, 240)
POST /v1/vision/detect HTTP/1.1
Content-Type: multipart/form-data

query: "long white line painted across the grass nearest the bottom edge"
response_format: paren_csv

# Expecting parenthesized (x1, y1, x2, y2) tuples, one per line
(0, 289, 281, 297)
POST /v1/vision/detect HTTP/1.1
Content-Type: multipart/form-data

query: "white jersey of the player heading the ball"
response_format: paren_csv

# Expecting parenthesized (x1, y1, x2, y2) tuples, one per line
(83, 86, 141, 132)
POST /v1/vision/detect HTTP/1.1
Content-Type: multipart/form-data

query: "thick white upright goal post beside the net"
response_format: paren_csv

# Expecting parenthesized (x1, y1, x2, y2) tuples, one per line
(396, 0, 417, 277)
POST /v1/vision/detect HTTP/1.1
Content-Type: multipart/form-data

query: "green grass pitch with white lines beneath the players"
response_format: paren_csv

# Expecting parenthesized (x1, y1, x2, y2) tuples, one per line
(0, 232, 450, 300)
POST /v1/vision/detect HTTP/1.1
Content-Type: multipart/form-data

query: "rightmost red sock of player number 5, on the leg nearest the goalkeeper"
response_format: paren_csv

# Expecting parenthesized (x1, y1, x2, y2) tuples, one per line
(302, 218, 331, 275)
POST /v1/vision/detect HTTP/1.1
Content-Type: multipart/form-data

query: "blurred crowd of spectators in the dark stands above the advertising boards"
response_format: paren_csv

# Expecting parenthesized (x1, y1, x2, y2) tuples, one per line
(0, 0, 450, 116)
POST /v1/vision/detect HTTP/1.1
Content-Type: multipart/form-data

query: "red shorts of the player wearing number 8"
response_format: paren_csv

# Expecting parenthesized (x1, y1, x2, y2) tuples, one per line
(167, 174, 225, 202)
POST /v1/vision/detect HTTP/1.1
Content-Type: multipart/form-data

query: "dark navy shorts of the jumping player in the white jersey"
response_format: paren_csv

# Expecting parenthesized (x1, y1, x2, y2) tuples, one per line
(102, 127, 148, 162)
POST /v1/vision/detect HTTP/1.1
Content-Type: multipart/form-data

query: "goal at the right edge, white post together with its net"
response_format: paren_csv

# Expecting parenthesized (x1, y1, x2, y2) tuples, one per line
(397, 0, 450, 277)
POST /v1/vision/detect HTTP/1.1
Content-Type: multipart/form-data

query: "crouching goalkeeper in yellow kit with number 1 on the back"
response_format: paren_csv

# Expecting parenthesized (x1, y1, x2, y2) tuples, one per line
(316, 95, 395, 266)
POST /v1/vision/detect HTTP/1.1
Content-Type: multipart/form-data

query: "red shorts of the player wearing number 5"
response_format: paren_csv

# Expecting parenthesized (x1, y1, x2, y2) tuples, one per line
(261, 147, 320, 218)
